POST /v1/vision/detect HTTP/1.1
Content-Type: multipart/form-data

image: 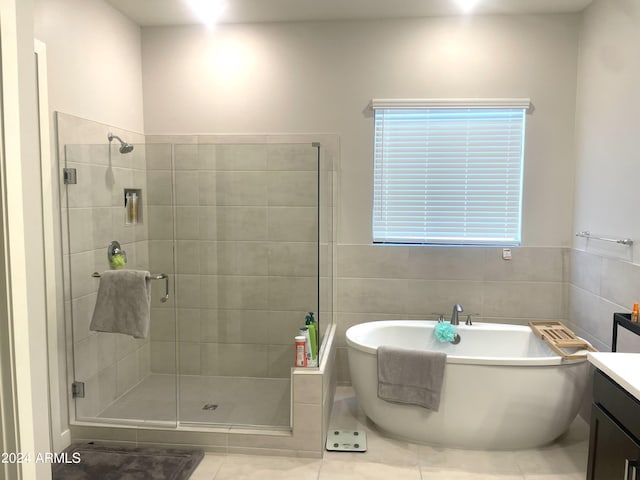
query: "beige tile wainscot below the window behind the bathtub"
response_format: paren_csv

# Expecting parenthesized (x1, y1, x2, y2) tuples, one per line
(336, 245, 570, 384)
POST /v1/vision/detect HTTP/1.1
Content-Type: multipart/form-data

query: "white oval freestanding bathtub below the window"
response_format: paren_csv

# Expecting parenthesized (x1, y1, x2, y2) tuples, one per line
(346, 320, 588, 450)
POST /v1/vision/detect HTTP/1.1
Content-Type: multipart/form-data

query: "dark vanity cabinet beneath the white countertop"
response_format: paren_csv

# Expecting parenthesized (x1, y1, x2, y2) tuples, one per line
(587, 370, 640, 480)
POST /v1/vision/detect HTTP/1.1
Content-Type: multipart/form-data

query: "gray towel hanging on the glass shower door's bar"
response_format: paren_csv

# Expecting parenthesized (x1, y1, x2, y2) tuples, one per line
(89, 270, 151, 338)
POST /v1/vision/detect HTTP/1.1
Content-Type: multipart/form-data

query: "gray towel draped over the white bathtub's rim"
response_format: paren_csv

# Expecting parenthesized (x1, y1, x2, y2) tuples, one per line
(378, 345, 447, 412)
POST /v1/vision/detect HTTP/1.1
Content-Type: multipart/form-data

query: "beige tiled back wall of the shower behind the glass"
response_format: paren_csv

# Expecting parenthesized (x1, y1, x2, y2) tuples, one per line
(147, 136, 331, 377)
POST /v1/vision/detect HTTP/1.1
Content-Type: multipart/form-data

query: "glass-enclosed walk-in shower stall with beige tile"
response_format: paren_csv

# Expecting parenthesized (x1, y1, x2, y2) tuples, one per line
(62, 134, 334, 430)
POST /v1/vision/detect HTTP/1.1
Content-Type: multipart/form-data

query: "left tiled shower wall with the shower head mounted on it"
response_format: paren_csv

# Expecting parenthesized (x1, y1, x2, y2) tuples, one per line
(58, 116, 150, 418)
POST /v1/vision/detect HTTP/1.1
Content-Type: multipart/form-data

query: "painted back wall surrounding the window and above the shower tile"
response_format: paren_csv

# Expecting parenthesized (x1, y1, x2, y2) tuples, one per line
(142, 15, 579, 246)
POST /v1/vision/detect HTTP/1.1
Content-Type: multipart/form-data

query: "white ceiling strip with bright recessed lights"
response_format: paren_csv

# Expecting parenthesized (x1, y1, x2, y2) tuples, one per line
(106, 0, 592, 26)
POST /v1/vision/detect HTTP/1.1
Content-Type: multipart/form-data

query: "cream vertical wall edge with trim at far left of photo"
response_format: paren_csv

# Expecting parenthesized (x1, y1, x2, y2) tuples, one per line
(0, 0, 51, 479)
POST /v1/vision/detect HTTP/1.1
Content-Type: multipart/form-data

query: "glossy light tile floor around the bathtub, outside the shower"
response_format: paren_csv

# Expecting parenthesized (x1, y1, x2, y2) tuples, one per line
(190, 387, 589, 480)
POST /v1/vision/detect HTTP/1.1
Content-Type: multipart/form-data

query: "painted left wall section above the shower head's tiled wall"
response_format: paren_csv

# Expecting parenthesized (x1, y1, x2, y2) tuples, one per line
(35, 0, 144, 133)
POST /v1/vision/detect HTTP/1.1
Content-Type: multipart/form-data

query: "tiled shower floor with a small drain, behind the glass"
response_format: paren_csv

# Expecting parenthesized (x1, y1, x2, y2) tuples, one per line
(98, 374, 291, 427)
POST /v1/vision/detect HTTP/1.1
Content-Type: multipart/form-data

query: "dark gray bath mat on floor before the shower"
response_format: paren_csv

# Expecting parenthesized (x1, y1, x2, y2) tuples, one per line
(51, 443, 204, 480)
